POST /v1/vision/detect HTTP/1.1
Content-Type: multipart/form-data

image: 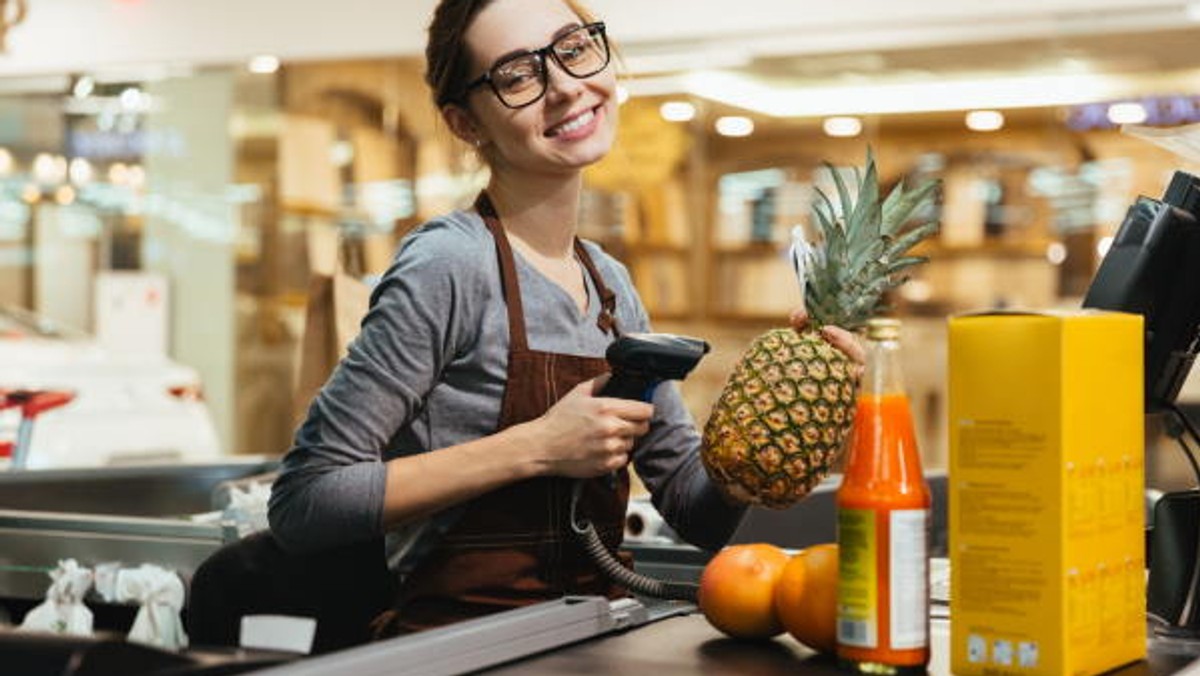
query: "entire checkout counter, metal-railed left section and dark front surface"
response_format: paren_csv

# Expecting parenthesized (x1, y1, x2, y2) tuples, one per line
(0, 470, 1200, 676)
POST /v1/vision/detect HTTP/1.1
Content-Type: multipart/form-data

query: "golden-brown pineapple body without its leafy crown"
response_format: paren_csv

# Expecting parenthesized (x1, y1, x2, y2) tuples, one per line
(701, 328, 858, 509)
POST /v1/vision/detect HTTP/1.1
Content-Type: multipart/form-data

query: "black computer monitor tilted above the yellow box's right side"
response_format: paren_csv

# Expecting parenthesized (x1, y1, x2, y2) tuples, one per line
(1084, 172, 1200, 413)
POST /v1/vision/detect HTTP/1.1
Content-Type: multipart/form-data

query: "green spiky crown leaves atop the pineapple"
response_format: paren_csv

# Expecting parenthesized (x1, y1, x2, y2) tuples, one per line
(802, 148, 940, 329)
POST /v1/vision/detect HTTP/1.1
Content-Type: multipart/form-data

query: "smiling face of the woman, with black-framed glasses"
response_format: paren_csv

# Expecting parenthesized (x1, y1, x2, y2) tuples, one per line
(441, 0, 617, 182)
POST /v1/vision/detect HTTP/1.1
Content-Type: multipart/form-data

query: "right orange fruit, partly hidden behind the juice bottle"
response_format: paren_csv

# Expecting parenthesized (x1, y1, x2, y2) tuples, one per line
(775, 544, 838, 652)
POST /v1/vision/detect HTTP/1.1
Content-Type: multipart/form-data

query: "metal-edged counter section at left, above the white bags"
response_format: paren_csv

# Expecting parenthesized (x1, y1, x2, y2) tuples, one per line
(0, 459, 276, 607)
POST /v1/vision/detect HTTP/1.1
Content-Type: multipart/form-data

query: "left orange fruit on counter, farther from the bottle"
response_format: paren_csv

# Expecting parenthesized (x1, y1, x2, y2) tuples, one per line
(698, 543, 788, 639)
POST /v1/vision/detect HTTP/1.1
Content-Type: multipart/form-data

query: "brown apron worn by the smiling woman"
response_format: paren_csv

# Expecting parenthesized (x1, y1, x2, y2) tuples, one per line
(394, 193, 629, 630)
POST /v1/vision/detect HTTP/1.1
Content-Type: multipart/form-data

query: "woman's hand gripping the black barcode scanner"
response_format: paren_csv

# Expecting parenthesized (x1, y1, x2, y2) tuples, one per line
(524, 381, 654, 479)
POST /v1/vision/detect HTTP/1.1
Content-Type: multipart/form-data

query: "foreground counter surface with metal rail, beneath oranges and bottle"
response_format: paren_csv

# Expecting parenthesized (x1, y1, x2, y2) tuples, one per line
(0, 597, 1200, 676)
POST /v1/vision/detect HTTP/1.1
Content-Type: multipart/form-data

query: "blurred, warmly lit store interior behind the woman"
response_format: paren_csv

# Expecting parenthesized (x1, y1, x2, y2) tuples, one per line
(0, 0, 1200, 489)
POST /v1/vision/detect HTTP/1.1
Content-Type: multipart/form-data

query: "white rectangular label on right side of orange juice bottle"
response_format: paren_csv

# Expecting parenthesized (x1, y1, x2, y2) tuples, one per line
(888, 509, 929, 650)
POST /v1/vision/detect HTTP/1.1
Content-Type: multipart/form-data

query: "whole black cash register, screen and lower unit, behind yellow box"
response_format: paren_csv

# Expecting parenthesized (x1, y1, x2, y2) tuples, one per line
(1084, 172, 1200, 638)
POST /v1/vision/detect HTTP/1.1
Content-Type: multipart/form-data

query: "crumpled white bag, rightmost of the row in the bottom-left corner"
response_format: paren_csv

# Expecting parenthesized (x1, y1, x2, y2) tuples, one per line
(116, 563, 187, 650)
